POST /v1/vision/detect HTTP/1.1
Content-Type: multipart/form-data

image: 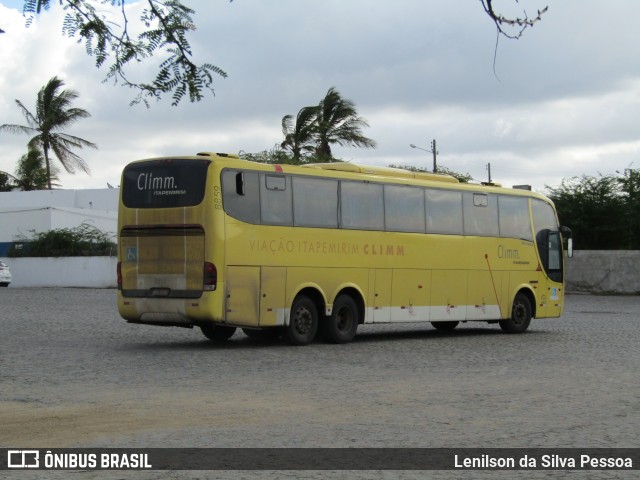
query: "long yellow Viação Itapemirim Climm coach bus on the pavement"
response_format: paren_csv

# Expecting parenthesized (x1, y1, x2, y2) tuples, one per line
(118, 153, 571, 345)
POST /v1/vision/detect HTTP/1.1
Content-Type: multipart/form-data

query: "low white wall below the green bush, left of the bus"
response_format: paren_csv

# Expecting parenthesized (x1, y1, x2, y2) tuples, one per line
(0, 257, 117, 288)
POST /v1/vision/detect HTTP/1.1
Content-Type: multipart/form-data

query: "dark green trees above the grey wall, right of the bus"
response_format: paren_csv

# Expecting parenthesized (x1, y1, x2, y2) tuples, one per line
(547, 169, 640, 250)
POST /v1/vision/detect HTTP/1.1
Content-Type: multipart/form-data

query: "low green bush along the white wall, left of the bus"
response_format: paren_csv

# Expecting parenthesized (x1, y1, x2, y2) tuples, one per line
(7, 223, 117, 257)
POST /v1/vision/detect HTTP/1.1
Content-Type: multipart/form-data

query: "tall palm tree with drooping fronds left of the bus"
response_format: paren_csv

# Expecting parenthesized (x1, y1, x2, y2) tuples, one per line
(0, 77, 97, 189)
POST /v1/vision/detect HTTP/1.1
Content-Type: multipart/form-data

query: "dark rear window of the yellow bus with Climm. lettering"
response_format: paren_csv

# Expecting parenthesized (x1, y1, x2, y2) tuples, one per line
(122, 159, 211, 208)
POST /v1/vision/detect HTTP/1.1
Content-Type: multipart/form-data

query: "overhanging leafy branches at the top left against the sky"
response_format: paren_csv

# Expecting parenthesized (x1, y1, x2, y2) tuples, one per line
(16, 0, 227, 106)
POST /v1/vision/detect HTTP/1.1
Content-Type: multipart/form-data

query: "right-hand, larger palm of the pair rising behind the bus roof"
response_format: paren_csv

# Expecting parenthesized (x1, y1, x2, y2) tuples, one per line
(316, 87, 376, 160)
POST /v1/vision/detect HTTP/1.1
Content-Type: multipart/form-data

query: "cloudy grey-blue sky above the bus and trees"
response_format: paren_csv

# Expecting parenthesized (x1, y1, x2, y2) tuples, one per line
(0, 0, 640, 191)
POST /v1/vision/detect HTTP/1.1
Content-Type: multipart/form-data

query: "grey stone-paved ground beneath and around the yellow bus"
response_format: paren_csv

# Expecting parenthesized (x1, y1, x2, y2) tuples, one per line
(0, 288, 640, 479)
